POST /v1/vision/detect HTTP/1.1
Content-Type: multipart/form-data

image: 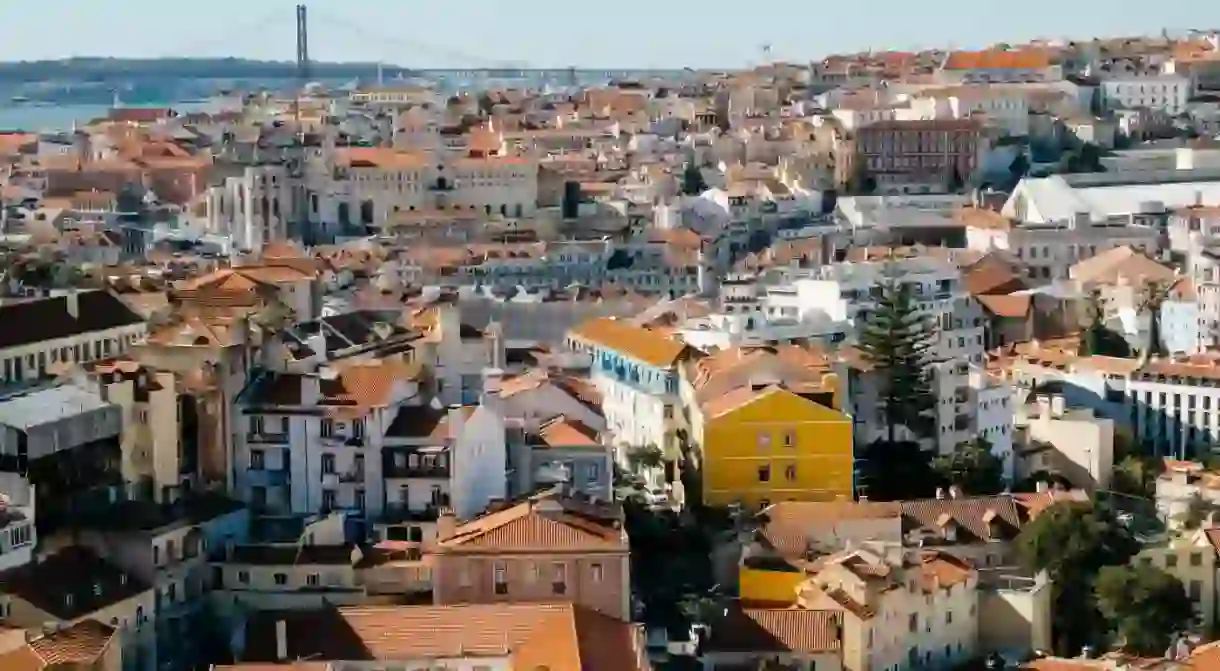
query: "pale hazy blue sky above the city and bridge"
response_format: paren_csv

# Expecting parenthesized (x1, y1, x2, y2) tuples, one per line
(0, 0, 1220, 67)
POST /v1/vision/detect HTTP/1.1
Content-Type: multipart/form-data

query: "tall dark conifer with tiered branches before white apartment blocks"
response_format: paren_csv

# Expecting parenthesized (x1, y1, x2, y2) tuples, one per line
(859, 266, 936, 444)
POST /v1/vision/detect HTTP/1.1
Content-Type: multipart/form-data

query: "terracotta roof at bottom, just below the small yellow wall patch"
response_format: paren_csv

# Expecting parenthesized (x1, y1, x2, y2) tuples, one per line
(706, 608, 843, 654)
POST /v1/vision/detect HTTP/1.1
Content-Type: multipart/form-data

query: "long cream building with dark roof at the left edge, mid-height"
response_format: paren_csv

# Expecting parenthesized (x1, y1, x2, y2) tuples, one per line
(0, 290, 146, 384)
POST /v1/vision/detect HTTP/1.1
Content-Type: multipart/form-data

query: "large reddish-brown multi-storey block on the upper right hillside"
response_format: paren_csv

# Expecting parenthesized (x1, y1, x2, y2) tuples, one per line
(856, 118, 987, 194)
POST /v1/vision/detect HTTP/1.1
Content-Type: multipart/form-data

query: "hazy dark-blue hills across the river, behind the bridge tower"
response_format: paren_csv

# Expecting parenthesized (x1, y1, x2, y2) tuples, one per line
(0, 59, 410, 84)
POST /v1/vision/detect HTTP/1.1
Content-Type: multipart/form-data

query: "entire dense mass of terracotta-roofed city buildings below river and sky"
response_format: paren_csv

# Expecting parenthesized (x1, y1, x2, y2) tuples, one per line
(0, 32, 1220, 671)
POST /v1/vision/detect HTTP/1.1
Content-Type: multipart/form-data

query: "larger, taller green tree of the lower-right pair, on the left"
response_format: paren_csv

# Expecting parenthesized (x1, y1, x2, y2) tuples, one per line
(1016, 501, 1139, 654)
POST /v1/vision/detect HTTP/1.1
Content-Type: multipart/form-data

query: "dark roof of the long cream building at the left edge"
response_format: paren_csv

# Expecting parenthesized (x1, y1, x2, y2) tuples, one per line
(0, 292, 144, 349)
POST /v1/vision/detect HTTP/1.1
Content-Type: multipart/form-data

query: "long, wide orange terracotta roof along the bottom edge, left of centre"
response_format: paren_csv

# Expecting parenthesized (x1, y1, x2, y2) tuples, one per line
(243, 603, 643, 671)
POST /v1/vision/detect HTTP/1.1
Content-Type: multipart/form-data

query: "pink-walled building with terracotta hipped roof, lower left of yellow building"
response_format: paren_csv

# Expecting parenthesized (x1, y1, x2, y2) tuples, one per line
(426, 492, 632, 621)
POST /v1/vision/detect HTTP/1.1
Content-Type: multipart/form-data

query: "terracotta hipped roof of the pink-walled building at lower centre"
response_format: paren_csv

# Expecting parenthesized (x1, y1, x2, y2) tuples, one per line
(436, 494, 627, 554)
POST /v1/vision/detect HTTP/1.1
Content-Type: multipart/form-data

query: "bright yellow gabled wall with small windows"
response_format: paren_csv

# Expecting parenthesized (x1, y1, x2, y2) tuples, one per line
(702, 389, 854, 508)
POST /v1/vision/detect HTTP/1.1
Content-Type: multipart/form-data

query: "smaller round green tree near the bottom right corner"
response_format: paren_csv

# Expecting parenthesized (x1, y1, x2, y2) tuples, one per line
(1094, 564, 1194, 655)
